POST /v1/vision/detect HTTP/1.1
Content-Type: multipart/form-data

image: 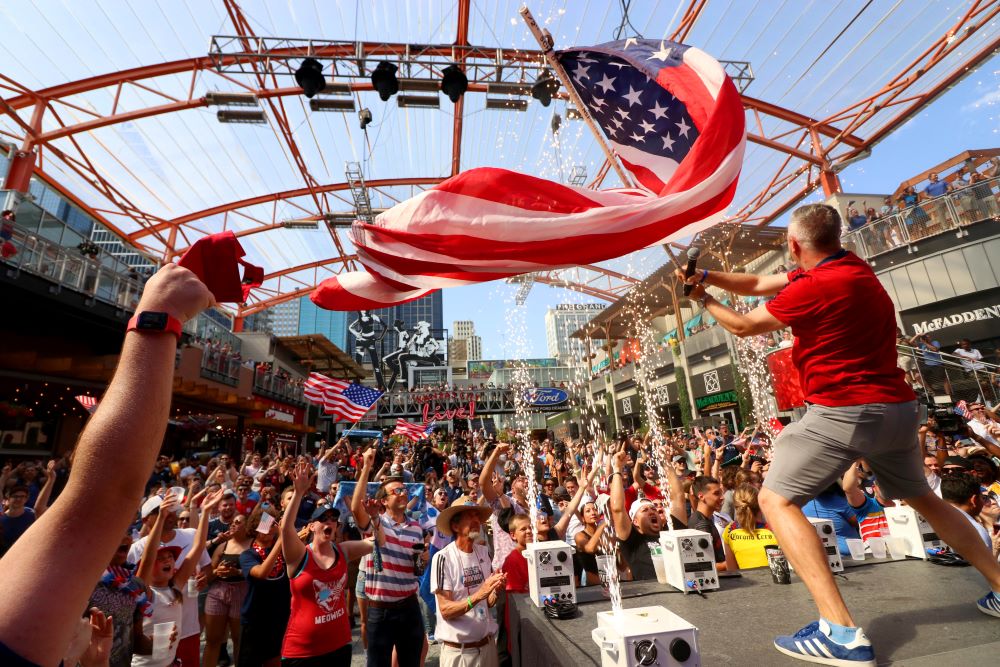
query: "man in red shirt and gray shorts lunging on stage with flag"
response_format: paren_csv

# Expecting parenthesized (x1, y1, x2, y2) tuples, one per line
(678, 204, 1000, 665)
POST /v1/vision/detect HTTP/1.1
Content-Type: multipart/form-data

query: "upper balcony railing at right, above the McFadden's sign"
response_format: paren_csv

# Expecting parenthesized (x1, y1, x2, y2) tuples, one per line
(843, 178, 1000, 259)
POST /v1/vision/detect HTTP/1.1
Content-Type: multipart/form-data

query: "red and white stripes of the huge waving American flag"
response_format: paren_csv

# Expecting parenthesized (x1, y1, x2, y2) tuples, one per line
(311, 44, 746, 310)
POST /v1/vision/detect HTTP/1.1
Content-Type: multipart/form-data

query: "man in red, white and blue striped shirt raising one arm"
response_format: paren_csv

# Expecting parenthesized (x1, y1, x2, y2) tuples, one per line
(351, 448, 424, 667)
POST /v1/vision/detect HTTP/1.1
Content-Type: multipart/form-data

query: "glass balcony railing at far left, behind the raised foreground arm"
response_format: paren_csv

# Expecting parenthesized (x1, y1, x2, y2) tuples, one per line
(0, 226, 144, 310)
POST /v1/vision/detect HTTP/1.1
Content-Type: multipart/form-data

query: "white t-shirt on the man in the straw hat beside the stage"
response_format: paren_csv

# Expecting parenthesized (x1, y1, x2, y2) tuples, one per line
(431, 542, 497, 644)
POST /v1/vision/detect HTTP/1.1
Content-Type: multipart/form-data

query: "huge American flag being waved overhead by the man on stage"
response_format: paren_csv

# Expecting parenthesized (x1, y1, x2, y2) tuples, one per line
(311, 39, 746, 310)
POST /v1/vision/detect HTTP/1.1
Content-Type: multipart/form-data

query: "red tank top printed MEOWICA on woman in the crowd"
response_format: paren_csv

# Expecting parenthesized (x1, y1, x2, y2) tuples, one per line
(281, 545, 351, 658)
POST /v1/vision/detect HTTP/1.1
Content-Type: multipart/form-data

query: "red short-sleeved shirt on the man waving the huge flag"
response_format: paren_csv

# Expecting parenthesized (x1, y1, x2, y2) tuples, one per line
(767, 251, 916, 407)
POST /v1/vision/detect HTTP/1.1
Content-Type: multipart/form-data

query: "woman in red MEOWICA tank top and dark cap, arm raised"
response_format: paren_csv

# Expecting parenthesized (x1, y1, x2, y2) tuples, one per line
(281, 463, 382, 667)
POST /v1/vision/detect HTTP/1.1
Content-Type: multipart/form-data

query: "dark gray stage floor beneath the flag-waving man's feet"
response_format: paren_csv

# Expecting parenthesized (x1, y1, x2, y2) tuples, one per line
(515, 560, 1000, 667)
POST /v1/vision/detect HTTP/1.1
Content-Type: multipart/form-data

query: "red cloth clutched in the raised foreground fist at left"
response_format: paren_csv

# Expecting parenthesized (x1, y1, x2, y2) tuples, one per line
(177, 231, 264, 303)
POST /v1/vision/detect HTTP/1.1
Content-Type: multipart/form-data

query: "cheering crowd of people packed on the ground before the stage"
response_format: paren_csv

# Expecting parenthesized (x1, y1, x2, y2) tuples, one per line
(0, 404, 1000, 667)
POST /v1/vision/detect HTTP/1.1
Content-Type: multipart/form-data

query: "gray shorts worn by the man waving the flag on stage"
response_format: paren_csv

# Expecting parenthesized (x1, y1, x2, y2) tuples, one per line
(764, 401, 930, 507)
